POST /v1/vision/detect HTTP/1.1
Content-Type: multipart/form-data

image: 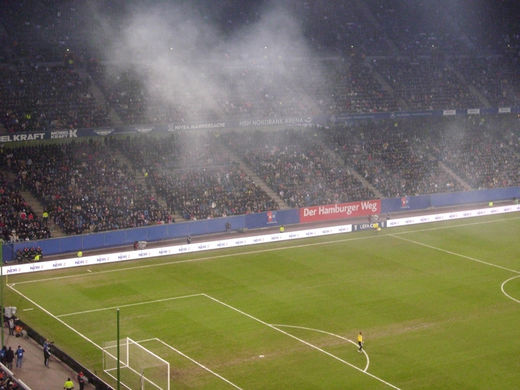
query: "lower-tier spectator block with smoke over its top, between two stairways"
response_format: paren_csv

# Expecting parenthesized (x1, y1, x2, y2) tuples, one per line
(112, 132, 277, 220)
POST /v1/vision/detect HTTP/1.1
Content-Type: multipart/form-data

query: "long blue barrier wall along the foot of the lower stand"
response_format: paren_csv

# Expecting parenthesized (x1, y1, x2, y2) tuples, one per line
(3, 187, 520, 261)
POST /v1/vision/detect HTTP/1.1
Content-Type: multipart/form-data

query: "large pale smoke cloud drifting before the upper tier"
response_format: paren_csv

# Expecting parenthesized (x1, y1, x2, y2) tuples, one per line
(87, 2, 326, 121)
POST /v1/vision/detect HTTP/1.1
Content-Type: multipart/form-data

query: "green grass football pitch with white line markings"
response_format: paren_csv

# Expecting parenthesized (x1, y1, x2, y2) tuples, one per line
(4, 213, 520, 390)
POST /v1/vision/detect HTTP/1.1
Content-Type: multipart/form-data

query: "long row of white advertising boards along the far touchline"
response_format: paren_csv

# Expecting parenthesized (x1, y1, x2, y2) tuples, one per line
(2, 205, 520, 275)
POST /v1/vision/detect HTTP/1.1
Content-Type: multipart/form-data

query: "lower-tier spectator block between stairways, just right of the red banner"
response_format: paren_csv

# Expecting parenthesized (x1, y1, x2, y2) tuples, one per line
(327, 119, 463, 197)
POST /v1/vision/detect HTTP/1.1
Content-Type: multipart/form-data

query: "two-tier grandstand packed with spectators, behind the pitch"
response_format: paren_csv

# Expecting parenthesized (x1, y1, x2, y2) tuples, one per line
(0, 0, 520, 385)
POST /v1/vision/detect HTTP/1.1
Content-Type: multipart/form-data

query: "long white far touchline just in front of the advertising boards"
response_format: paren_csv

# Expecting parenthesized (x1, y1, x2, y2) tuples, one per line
(13, 217, 520, 285)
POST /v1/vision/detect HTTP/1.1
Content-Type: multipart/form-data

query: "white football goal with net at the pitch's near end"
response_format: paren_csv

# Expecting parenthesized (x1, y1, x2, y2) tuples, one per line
(103, 337, 170, 390)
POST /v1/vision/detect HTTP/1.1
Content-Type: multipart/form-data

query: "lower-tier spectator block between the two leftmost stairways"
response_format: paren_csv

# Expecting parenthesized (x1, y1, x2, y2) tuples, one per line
(4, 141, 171, 234)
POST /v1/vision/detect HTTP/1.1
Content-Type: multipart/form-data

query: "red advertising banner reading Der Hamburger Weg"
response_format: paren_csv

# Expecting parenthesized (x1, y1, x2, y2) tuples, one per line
(300, 199, 381, 222)
